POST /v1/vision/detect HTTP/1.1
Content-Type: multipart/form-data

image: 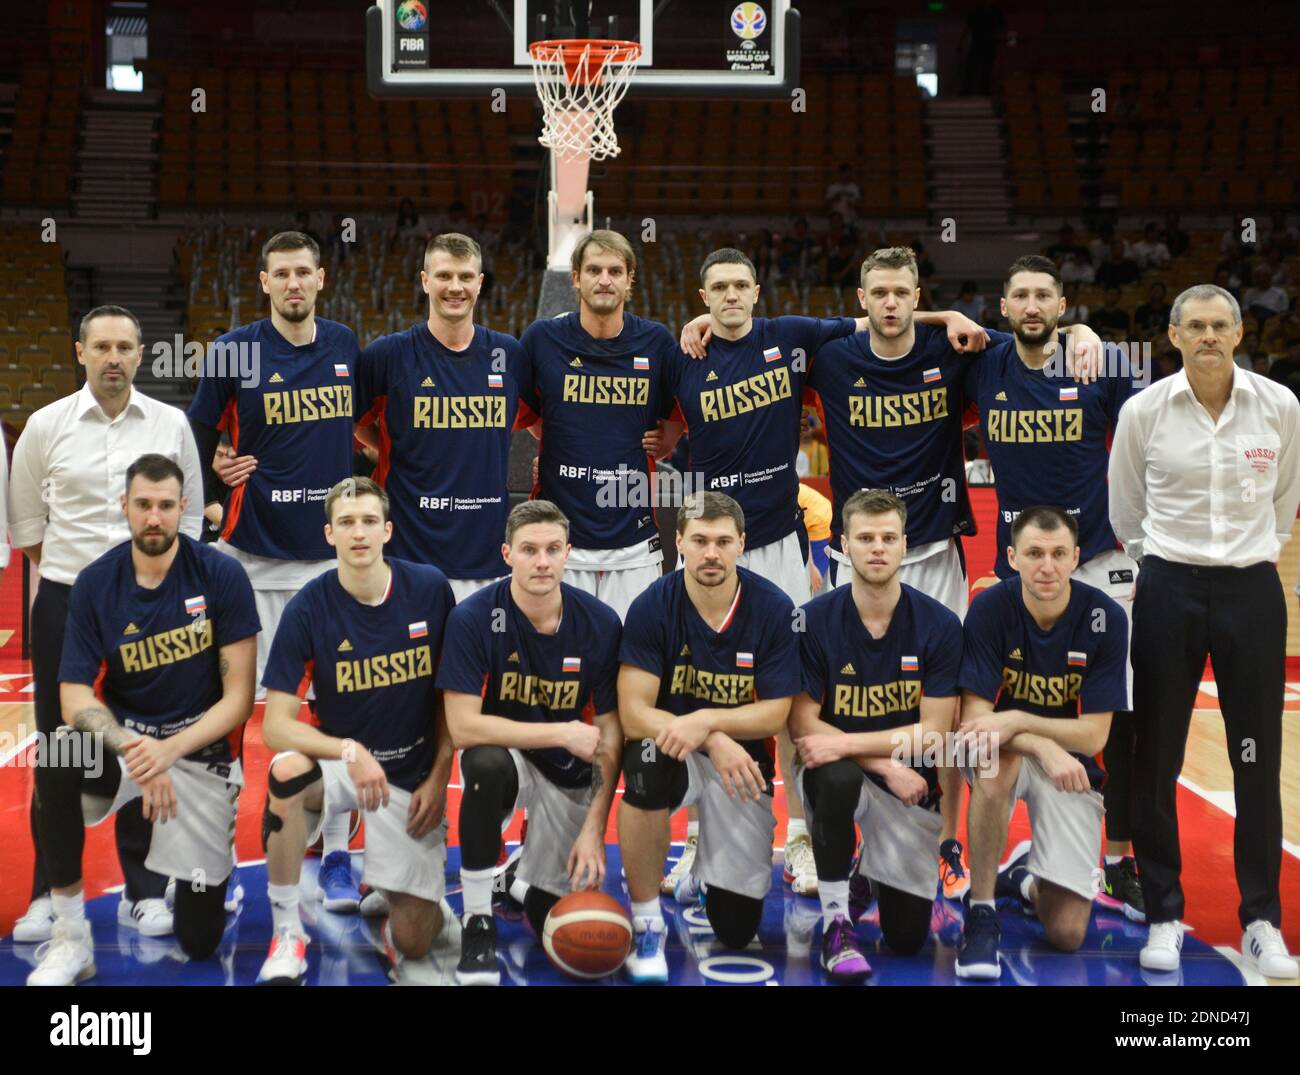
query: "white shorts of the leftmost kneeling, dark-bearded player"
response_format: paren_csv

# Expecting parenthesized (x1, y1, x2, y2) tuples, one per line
(82, 755, 243, 885)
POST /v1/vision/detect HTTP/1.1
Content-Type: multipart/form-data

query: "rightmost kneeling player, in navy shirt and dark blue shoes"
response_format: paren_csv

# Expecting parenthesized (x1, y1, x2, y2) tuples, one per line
(957, 507, 1128, 978)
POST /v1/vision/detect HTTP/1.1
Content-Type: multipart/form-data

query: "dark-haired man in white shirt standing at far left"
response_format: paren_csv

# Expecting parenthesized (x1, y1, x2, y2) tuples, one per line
(8, 305, 203, 942)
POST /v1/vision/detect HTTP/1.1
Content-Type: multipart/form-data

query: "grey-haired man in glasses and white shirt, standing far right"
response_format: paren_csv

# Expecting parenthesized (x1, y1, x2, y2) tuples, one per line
(1109, 283, 1300, 978)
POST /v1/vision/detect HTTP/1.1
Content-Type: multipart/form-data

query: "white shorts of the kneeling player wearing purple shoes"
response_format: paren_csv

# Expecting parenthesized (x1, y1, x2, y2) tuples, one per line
(794, 766, 944, 900)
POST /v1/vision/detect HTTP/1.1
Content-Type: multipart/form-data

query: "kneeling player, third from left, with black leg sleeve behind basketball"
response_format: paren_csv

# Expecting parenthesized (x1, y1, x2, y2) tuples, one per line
(438, 500, 623, 985)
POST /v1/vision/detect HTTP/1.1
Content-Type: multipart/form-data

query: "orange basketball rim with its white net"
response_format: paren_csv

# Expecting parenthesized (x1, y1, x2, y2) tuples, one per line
(529, 42, 641, 162)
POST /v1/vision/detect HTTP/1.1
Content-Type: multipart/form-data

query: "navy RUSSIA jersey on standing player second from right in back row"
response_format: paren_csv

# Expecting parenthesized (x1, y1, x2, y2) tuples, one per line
(809, 325, 975, 549)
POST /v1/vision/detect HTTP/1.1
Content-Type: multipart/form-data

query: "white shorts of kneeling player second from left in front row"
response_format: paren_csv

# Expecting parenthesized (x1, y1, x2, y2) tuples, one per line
(282, 751, 447, 903)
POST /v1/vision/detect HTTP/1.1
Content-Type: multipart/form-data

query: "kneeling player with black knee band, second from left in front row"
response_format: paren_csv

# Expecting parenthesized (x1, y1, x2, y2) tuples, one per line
(257, 478, 455, 985)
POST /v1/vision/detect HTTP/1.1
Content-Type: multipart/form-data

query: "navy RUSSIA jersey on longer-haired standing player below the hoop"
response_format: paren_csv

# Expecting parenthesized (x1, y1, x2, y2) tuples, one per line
(520, 312, 680, 549)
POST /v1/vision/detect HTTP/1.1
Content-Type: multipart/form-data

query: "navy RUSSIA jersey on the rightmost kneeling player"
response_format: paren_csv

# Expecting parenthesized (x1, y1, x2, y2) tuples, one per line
(959, 575, 1128, 788)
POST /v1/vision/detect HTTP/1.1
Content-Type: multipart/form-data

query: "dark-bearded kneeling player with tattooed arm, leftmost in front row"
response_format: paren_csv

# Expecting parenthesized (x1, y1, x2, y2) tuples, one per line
(27, 455, 259, 985)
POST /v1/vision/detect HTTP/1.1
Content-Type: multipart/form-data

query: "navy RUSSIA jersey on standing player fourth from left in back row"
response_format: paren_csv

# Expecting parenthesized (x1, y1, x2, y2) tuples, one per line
(672, 317, 857, 549)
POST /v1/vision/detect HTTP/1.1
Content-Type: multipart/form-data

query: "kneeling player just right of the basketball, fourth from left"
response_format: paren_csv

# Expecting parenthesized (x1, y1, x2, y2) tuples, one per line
(613, 493, 800, 983)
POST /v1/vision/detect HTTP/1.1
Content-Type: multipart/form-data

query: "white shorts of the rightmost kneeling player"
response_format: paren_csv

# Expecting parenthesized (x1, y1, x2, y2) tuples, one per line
(966, 755, 1106, 900)
